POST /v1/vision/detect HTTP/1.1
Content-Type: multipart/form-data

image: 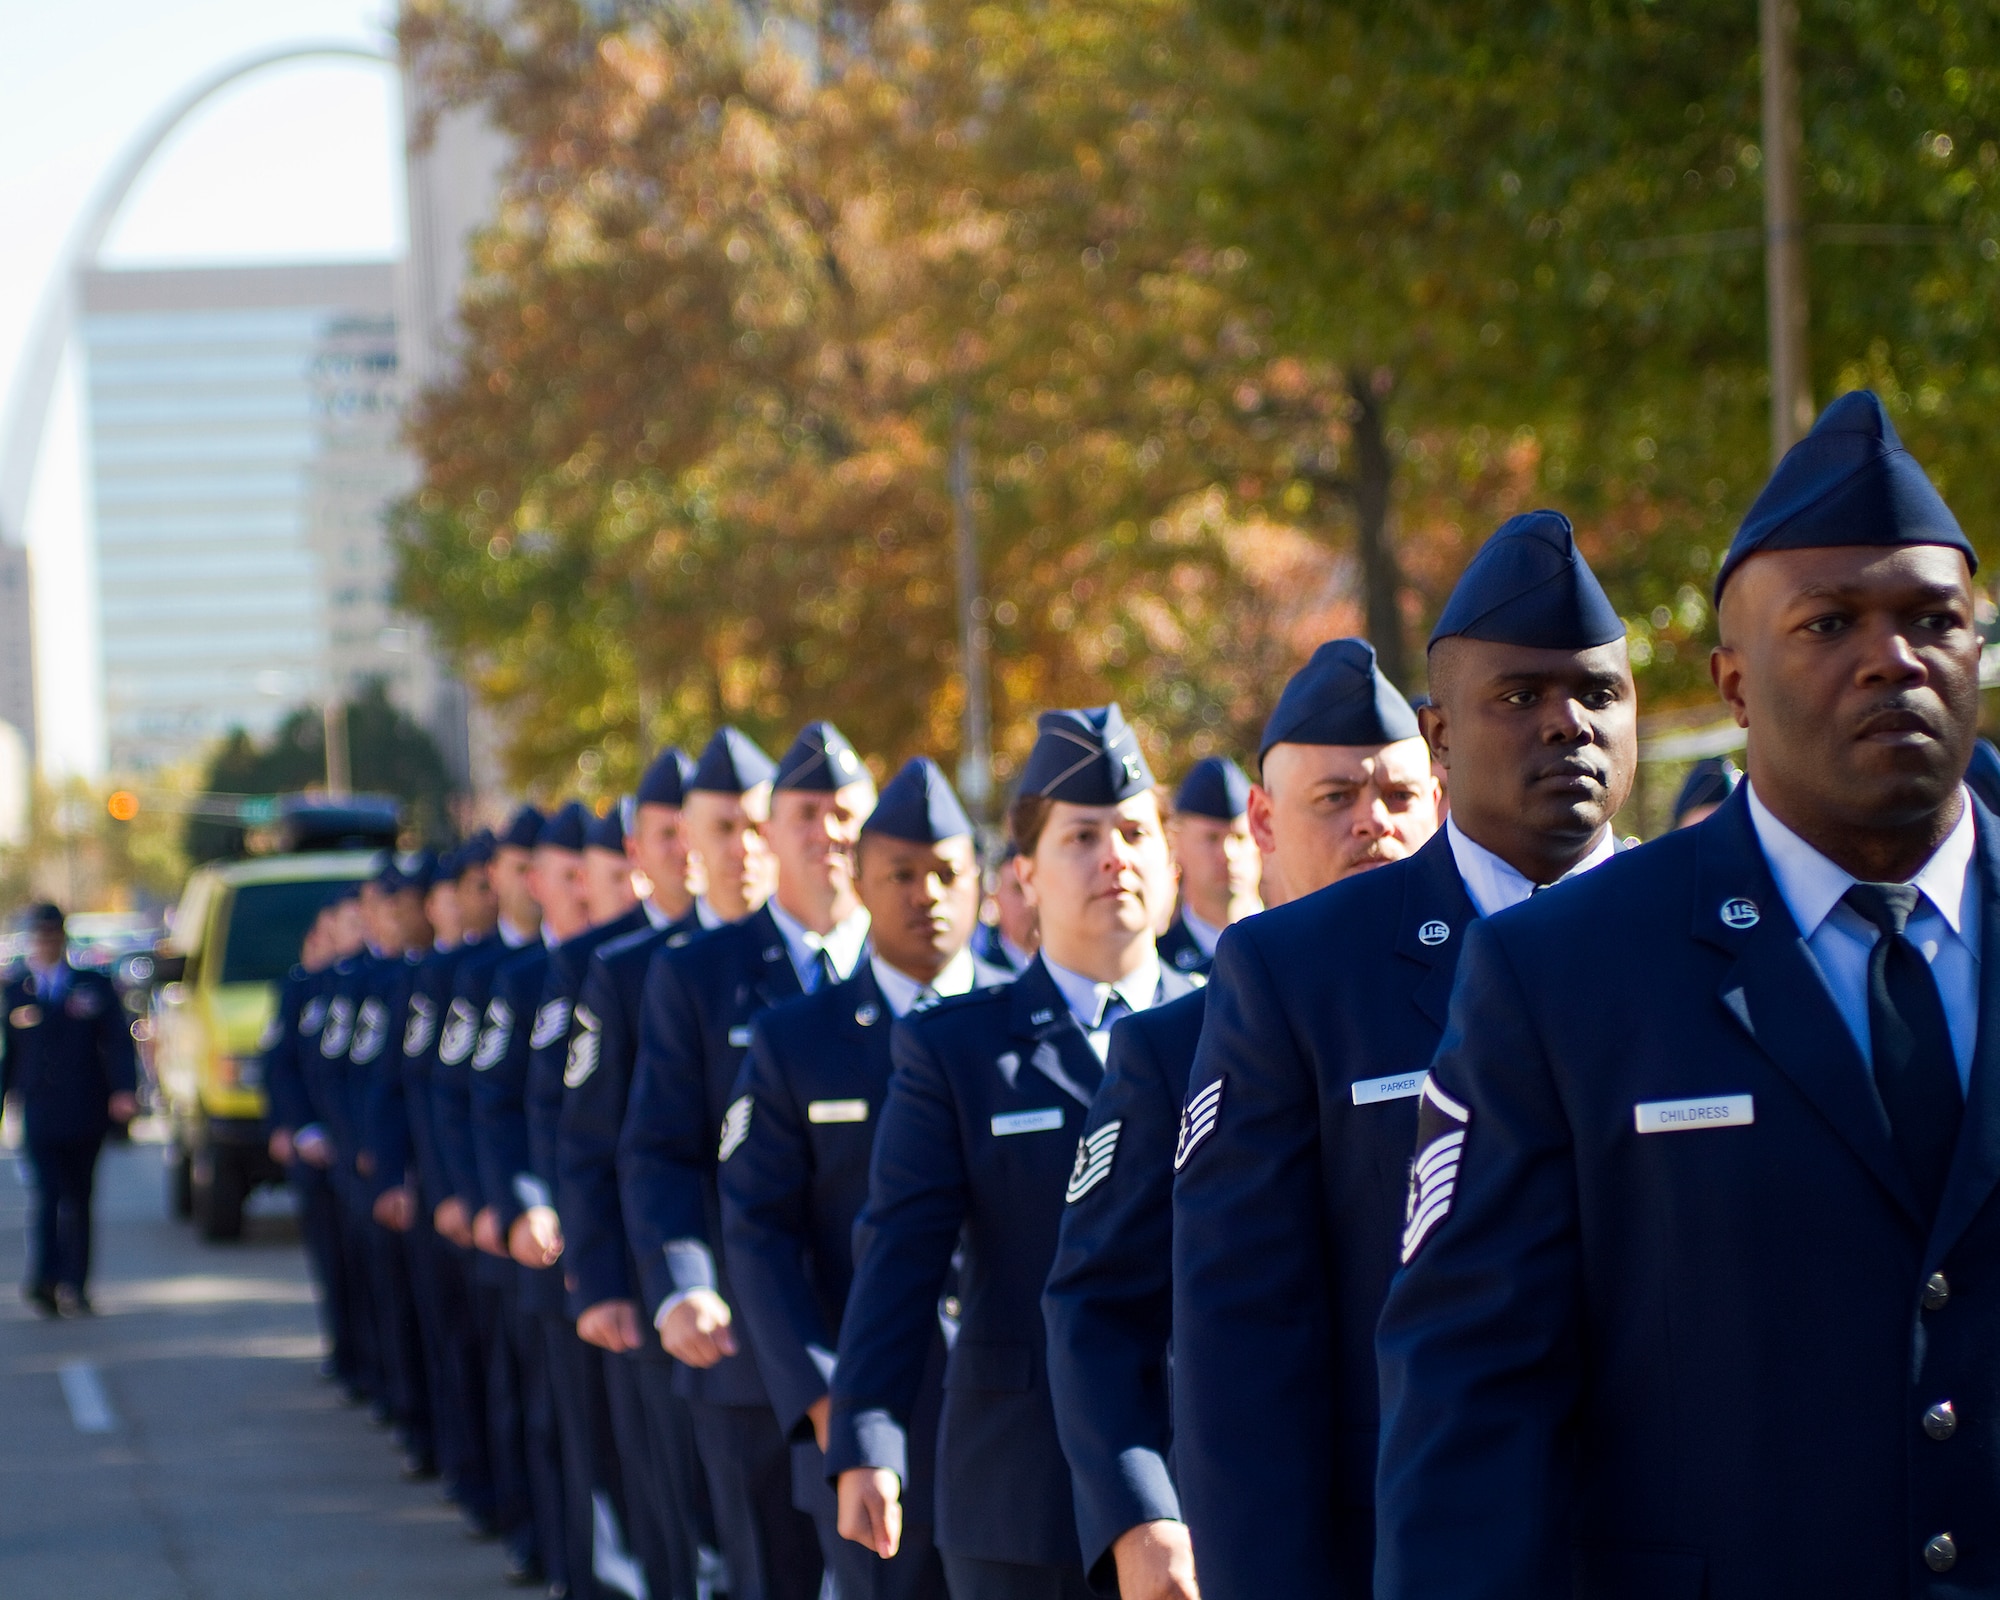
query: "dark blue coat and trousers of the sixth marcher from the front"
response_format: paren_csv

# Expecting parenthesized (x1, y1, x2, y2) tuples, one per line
(618, 910, 822, 1600)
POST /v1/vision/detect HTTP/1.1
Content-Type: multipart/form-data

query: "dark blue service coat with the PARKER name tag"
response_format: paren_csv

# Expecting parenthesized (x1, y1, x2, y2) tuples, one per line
(1172, 828, 1472, 1600)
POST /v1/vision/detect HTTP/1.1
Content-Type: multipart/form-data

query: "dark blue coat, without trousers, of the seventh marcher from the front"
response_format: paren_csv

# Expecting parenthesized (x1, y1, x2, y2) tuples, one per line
(556, 912, 702, 1320)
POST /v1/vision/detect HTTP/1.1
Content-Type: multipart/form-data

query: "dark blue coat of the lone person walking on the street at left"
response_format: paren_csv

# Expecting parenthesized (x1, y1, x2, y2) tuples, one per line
(0, 964, 138, 1144)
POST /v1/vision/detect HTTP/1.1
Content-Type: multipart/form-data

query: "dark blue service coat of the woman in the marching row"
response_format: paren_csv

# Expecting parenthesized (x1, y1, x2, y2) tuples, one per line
(826, 958, 1188, 1566)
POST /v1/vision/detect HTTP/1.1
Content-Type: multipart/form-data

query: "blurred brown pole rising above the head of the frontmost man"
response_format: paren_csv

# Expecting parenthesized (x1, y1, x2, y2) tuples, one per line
(1758, 0, 1812, 464)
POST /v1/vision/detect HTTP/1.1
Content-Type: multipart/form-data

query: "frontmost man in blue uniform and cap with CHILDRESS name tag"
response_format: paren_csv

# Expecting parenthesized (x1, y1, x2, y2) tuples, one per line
(1384, 394, 2000, 1600)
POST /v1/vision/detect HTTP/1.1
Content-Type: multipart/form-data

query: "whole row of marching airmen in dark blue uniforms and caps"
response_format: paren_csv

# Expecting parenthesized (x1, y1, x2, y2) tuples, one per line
(270, 392, 2000, 1600)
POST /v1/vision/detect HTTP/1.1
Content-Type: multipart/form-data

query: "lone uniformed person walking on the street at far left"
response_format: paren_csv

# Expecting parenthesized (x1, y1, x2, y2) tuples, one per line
(0, 906, 138, 1316)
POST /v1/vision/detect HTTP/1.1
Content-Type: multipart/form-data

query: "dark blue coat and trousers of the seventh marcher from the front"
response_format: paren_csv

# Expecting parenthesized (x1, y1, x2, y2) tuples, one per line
(556, 912, 716, 1600)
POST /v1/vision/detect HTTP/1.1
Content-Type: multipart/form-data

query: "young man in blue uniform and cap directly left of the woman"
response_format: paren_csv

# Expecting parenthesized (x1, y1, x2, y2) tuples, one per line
(722, 756, 1010, 1600)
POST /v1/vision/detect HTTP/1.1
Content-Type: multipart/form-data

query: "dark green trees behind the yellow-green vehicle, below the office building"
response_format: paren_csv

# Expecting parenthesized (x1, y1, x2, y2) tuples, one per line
(182, 678, 452, 864)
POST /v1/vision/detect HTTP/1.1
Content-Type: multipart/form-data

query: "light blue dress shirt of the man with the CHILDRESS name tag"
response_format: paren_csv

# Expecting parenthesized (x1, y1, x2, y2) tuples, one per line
(1750, 788, 1980, 1092)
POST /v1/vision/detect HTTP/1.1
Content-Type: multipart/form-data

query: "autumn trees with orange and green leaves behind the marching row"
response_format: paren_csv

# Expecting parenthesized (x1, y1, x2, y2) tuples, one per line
(398, 0, 2000, 800)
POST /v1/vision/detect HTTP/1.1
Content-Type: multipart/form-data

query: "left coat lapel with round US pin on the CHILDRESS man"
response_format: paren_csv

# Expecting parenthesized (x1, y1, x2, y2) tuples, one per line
(1692, 788, 1924, 1224)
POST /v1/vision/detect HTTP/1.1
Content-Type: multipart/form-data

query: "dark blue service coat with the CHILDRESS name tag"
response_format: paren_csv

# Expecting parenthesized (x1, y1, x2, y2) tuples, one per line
(1384, 788, 2000, 1600)
